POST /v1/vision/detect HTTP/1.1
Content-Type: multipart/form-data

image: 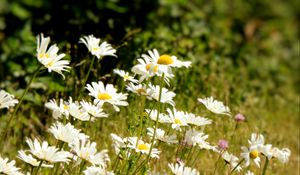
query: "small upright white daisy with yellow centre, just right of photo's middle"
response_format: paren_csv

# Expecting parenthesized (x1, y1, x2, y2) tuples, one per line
(167, 108, 188, 130)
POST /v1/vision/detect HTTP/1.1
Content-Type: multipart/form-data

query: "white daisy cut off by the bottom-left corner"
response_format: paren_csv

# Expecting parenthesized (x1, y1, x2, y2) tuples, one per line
(0, 156, 23, 175)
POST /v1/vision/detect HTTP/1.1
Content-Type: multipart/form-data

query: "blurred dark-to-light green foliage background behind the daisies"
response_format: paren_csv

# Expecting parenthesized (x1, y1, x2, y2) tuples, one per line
(0, 0, 300, 173)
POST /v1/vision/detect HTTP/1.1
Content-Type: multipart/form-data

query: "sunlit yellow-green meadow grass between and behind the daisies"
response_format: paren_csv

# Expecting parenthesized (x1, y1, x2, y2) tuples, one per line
(1, 36, 299, 174)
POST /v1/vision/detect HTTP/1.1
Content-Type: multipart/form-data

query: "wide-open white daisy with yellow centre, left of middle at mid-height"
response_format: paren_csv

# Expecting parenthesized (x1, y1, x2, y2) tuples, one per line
(86, 81, 128, 111)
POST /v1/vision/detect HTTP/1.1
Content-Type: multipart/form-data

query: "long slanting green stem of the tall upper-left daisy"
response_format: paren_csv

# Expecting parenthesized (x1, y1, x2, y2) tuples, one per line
(2, 64, 42, 147)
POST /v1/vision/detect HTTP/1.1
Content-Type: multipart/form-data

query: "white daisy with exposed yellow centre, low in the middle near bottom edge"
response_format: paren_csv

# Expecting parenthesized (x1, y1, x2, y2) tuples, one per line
(128, 137, 160, 158)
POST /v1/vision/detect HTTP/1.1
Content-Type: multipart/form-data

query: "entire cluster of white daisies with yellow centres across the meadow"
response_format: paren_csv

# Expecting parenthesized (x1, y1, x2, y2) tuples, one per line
(0, 34, 291, 175)
